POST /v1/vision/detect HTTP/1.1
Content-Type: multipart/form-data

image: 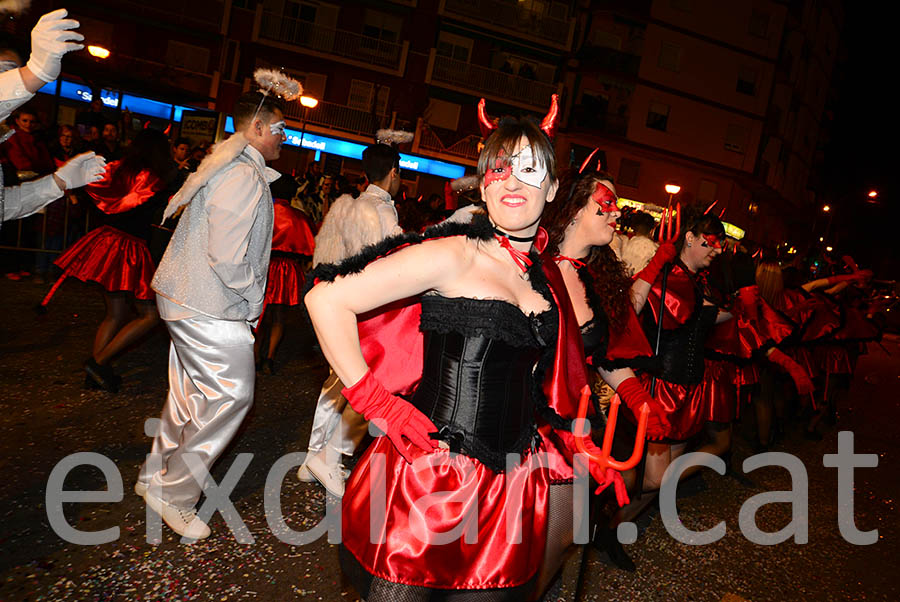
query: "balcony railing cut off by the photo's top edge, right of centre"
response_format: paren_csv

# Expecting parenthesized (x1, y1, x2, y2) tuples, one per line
(444, 0, 575, 49)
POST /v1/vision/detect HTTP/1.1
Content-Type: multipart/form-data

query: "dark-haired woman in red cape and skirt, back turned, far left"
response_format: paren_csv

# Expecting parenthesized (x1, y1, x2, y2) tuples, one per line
(42, 129, 175, 392)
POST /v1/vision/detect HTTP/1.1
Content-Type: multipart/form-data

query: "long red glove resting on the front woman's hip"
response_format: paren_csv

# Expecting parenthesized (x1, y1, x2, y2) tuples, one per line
(341, 370, 438, 463)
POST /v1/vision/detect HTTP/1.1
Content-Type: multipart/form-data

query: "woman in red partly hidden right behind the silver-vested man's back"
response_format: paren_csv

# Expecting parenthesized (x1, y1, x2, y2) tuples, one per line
(253, 173, 315, 374)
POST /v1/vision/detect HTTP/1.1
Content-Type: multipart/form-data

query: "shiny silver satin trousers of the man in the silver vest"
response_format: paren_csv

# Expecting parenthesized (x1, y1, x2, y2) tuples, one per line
(138, 317, 256, 508)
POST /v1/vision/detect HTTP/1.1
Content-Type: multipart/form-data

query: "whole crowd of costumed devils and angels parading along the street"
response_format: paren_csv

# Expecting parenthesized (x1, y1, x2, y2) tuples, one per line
(0, 11, 880, 602)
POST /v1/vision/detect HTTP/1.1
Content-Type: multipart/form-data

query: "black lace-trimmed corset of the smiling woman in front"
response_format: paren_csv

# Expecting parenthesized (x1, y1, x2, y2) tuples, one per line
(411, 295, 555, 472)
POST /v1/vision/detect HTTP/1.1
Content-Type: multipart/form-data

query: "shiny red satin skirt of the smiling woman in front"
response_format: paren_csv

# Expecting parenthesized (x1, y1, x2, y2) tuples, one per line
(342, 437, 549, 589)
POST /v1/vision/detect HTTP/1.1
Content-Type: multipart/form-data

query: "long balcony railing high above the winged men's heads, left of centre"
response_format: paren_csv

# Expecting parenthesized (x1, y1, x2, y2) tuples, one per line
(259, 11, 406, 72)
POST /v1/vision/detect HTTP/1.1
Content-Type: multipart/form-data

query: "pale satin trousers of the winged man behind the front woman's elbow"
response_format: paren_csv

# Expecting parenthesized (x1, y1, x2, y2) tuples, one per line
(308, 370, 369, 456)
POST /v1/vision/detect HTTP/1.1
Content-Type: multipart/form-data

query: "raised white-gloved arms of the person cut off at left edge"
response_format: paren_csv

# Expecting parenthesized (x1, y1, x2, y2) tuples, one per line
(0, 8, 105, 223)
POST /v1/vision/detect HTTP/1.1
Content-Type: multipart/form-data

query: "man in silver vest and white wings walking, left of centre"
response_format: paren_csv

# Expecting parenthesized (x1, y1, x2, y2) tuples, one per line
(135, 92, 285, 540)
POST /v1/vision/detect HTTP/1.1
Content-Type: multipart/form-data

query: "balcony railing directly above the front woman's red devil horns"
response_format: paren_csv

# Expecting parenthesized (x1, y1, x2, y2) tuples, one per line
(428, 49, 558, 109)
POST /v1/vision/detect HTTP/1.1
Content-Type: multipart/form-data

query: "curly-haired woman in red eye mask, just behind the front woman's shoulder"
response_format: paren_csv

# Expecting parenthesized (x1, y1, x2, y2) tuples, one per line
(541, 162, 667, 571)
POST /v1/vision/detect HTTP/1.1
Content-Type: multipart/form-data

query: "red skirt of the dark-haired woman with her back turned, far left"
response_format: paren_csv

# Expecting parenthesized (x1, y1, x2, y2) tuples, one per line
(54, 226, 156, 301)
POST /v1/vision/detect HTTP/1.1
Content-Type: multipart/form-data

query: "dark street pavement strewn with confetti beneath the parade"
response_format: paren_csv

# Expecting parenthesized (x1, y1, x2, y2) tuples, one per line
(0, 279, 900, 602)
